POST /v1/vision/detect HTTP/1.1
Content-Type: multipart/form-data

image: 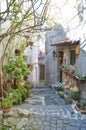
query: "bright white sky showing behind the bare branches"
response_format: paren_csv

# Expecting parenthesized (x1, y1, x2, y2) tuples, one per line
(0, 0, 79, 49)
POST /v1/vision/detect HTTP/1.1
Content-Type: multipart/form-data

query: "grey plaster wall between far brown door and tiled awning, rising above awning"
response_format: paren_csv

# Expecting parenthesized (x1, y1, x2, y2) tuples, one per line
(44, 26, 67, 83)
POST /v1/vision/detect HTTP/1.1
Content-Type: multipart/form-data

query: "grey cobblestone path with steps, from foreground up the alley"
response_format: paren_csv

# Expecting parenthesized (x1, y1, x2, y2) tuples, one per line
(16, 84, 86, 130)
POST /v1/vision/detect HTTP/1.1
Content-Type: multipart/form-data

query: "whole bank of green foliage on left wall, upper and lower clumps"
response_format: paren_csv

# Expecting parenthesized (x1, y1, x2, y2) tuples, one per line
(3, 45, 31, 105)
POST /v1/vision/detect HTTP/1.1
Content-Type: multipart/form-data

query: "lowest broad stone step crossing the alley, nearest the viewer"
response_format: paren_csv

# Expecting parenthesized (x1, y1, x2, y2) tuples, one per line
(14, 105, 86, 119)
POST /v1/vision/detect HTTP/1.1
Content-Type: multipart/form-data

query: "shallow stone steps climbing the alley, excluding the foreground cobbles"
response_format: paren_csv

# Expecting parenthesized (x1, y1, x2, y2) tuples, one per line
(14, 83, 86, 119)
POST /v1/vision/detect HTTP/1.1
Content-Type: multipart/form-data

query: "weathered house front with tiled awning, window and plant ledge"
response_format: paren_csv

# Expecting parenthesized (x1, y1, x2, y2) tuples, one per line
(52, 40, 86, 99)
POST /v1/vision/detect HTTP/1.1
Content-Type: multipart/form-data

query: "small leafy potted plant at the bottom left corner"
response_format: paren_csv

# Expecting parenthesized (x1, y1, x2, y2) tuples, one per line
(2, 97, 13, 113)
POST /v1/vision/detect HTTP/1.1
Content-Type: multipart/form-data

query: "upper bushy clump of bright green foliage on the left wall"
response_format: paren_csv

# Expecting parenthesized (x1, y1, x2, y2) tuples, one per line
(3, 53, 31, 85)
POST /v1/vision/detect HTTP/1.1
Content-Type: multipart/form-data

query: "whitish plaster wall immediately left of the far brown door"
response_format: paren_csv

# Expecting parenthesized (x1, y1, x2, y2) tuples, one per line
(25, 44, 39, 83)
